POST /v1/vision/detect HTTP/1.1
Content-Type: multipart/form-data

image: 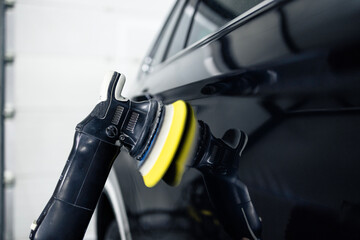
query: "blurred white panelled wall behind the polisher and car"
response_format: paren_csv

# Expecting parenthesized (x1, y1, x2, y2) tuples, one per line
(1, 0, 174, 240)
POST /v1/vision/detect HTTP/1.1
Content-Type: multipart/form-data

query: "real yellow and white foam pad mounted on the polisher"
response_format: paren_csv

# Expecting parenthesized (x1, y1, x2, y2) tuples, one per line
(139, 100, 188, 187)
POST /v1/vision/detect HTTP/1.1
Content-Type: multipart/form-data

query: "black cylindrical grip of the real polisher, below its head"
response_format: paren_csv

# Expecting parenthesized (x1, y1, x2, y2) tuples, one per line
(30, 131, 120, 240)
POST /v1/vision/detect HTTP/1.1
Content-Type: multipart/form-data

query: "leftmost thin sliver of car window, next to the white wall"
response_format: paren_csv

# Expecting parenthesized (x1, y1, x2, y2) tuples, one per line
(152, 0, 185, 65)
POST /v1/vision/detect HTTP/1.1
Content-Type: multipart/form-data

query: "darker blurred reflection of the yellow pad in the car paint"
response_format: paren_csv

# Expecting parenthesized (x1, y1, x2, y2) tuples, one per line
(163, 104, 198, 186)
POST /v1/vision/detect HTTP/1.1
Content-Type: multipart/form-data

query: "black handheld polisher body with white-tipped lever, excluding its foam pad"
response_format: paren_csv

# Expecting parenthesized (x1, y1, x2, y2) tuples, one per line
(30, 72, 161, 240)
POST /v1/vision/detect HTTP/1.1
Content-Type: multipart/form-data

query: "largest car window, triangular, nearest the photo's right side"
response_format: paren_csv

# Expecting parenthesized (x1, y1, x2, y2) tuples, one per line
(186, 0, 263, 46)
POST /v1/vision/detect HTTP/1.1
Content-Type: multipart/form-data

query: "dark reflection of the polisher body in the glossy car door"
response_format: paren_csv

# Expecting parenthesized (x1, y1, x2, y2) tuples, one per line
(193, 124, 261, 240)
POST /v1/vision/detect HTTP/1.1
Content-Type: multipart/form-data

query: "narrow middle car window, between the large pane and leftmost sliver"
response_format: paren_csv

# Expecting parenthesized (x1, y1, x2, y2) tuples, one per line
(164, 1, 197, 60)
